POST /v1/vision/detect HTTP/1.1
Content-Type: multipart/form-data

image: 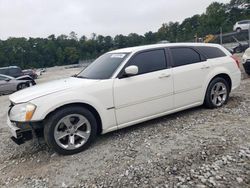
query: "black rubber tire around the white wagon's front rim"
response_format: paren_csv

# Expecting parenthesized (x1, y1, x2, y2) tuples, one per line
(44, 106, 97, 155)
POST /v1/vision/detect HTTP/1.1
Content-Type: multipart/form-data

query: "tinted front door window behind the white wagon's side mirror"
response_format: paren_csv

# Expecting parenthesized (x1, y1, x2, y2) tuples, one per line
(129, 50, 166, 74)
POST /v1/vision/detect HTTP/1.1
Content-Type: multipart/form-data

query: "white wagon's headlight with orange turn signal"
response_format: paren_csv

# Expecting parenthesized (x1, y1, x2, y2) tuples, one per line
(9, 103, 36, 122)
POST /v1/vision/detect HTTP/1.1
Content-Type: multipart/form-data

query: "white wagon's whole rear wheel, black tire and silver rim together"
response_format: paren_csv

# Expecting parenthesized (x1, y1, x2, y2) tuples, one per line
(204, 77, 229, 108)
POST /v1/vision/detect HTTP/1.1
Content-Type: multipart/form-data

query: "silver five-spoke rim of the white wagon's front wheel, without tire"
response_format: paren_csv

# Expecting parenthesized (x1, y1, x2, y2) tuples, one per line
(54, 114, 91, 150)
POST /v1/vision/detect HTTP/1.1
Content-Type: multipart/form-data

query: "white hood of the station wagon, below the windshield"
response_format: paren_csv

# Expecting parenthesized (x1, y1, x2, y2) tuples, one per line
(9, 77, 98, 104)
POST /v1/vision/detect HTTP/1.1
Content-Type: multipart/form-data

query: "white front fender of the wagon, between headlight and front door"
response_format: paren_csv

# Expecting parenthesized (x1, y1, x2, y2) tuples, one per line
(30, 85, 117, 130)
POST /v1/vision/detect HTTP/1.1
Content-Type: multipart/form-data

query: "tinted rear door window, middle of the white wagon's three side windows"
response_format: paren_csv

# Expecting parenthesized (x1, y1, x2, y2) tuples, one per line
(170, 47, 201, 67)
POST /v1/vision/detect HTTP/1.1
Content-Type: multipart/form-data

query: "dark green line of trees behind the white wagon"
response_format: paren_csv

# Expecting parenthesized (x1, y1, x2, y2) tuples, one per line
(0, 0, 250, 68)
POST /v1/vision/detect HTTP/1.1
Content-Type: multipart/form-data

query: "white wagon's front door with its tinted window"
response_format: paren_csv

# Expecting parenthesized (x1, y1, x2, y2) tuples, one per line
(113, 49, 173, 128)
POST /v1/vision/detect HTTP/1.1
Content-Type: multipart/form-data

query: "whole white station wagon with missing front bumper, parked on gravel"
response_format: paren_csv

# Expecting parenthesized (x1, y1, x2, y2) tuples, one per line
(8, 43, 241, 155)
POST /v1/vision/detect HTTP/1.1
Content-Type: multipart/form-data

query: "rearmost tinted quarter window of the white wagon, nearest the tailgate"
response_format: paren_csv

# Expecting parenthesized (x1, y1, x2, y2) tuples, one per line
(196, 46, 226, 59)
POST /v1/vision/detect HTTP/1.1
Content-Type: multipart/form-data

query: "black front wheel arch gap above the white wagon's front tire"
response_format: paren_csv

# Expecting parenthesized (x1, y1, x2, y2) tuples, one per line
(44, 102, 103, 134)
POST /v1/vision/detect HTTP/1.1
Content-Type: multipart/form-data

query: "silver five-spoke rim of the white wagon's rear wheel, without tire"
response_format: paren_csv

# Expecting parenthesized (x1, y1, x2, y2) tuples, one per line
(211, 82, 228, 107)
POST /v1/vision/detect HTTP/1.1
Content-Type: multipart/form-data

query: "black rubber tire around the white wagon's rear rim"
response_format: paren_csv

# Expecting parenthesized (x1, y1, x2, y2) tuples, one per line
(204, 77, 230, 109)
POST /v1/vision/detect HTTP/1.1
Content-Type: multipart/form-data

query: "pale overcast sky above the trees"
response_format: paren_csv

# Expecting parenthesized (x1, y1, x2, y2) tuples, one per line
(0, 0, 229, 39)
